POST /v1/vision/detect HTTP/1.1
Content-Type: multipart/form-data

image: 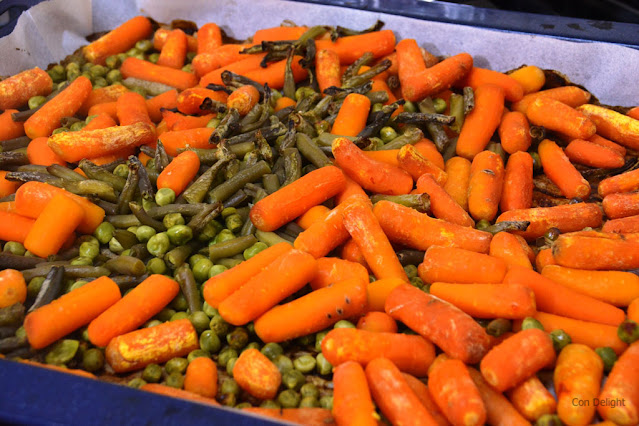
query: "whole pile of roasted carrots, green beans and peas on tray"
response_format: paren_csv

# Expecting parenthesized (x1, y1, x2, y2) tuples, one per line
(0, 11, 639, 425)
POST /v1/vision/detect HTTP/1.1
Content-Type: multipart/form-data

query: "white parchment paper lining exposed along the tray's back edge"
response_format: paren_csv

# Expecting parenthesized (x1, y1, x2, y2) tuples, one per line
(0, 0, 639, 106)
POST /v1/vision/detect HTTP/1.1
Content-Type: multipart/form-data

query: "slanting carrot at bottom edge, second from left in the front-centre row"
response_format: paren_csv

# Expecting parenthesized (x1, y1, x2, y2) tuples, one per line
(366, 358, 437, 426)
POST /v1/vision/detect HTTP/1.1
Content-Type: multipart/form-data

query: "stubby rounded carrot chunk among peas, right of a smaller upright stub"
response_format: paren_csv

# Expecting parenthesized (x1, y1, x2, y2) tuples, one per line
(233, 348, 282, 399)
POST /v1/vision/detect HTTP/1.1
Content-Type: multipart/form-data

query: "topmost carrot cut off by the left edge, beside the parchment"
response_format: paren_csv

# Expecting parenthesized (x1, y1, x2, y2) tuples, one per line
(0, 67, 53, 111)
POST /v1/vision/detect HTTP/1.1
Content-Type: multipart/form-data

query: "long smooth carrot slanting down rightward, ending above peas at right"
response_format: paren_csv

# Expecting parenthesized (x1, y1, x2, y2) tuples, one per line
(504, 266, 625, 326)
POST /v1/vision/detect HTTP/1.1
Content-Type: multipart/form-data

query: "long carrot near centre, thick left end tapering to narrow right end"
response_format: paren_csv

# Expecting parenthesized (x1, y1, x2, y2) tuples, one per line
(373, 201, 492, 253)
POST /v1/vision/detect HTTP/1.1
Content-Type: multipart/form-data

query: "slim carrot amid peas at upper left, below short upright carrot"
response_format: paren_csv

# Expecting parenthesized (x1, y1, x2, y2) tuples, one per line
(120, 57, 197, 90)
